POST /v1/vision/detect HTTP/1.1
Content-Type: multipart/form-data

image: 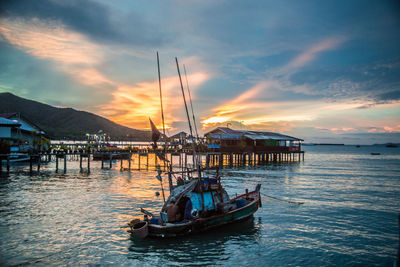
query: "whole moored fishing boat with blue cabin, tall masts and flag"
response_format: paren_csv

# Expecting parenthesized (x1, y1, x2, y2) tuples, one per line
(128, 53, 261, 238)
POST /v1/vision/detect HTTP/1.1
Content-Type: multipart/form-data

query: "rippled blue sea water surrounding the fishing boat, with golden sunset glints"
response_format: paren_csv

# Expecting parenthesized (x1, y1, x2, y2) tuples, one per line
(0, 146, 400, 266)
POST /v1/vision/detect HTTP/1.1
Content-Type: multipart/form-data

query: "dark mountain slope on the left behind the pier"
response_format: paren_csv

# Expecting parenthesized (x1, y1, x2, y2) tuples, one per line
(0, 93, 151, 141)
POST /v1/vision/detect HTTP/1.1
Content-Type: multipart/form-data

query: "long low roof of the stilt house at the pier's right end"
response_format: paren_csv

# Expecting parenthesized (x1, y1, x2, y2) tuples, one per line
(204, 127, 304, 141)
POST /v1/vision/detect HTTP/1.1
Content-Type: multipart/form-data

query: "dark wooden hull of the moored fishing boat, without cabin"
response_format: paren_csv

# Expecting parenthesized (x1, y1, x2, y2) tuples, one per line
(148, 191, 261, 237)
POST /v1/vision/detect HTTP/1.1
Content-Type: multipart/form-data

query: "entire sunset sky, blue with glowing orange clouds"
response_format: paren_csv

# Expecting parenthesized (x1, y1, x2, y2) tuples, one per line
(0, 0, 400, 144)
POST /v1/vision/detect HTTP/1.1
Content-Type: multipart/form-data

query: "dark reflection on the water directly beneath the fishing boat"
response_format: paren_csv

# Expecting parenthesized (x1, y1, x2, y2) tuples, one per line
(129, 218, 262, 264)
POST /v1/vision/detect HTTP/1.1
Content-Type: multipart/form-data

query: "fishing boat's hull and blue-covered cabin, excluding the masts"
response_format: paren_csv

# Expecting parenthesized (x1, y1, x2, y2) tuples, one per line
(130, 171, 261, 238)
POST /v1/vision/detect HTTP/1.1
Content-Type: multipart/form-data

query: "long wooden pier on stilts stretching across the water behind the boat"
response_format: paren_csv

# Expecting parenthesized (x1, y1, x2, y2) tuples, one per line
(0, 150, 304, 174)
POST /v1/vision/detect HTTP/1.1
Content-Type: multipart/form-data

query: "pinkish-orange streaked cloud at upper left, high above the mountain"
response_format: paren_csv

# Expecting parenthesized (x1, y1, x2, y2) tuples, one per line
(0, 18, 115, 92)
